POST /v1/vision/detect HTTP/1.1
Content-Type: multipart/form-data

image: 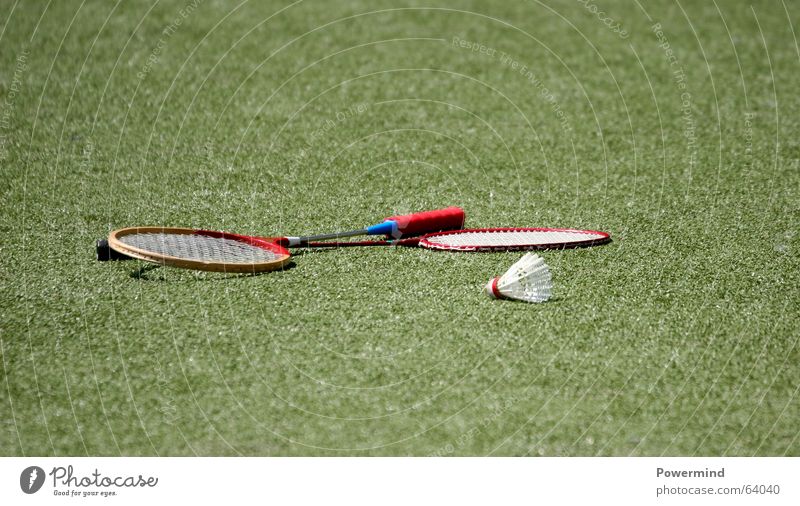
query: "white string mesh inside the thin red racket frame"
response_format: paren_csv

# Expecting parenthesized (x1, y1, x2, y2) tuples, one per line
(426, 230, 605, 247)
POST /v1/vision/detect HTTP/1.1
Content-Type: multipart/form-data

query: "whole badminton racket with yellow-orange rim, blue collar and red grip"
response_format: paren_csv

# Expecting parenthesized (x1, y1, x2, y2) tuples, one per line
(97, 207, 465, 272)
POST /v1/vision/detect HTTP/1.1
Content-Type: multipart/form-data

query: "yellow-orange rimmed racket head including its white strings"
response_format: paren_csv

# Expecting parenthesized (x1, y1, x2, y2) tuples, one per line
(108, 227, 291, 273)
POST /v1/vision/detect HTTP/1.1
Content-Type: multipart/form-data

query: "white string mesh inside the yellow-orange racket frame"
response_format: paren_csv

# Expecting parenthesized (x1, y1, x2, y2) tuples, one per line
(119, 233, 284, 264)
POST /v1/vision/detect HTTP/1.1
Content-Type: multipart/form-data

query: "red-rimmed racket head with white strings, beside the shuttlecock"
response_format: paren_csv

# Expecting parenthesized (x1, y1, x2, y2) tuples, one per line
(419, 227, 611, 251)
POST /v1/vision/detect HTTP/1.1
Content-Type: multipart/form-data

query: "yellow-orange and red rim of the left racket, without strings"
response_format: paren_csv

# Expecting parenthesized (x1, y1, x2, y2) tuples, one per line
(108, 227, 291, 273)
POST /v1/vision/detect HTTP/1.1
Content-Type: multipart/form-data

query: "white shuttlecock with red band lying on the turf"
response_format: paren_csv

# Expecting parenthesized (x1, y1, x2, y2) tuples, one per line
(486, 253, 553, 302)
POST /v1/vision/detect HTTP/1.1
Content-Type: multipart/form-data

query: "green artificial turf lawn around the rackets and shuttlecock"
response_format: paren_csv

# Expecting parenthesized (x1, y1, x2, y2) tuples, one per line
(0, 0, 800, 455)
